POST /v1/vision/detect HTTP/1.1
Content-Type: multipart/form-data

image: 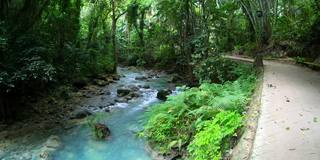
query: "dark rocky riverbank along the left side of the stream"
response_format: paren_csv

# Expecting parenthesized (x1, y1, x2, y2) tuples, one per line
(0, 75, 119, 159)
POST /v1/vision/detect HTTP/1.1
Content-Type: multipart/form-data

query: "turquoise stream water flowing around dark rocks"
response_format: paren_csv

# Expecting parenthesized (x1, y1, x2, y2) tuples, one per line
(53, 68, 175, 160)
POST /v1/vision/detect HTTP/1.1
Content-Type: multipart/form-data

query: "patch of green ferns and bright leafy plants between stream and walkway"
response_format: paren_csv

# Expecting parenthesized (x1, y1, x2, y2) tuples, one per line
(144, 62, 256, 159)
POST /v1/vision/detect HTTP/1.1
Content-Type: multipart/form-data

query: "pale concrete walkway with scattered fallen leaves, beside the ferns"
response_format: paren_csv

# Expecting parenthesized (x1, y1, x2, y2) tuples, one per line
(250, 62, 320, 160)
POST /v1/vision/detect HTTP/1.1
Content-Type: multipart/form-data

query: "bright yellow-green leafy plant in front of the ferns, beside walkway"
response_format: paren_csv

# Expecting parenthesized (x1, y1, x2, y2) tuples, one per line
(188, 111, 243, 160)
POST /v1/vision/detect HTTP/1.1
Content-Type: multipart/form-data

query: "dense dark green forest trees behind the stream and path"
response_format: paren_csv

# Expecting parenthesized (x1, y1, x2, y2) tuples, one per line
(0, 0, 320, 125)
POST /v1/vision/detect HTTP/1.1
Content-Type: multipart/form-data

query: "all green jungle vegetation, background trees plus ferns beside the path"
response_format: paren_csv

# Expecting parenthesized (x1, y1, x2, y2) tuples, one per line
(0, 0, 320, 159)
